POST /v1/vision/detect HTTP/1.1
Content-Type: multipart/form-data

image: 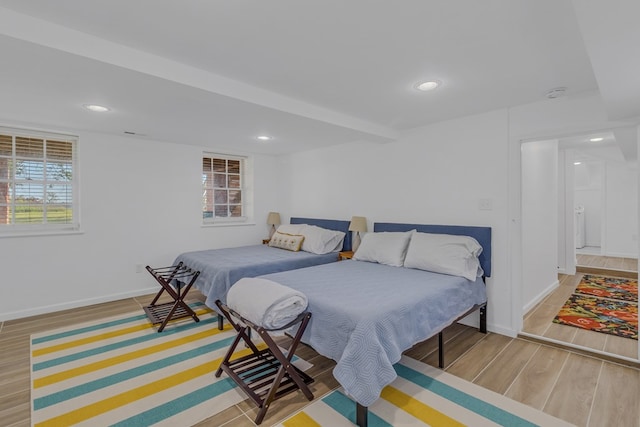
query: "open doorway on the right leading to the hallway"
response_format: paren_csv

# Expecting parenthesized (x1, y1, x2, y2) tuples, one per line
(521, 131, 638, 360)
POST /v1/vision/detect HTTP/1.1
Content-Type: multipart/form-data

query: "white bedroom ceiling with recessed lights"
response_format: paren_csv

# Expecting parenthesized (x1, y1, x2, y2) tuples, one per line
(0, 0, 640, 154)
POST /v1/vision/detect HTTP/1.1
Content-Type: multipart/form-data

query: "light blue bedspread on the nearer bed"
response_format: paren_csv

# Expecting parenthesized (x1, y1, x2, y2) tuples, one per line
(264, 260, 487, 406)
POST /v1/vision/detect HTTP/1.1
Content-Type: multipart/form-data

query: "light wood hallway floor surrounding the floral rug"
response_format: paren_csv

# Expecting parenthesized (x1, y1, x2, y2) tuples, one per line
(523, 255, 638, 359)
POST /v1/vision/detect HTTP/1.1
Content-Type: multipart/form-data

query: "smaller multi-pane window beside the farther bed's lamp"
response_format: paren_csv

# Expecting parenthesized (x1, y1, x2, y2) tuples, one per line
(202, 154, 247, 223)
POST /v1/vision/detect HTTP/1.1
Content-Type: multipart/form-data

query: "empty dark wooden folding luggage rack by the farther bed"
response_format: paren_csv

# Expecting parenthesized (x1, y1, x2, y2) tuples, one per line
(144, 262, 200, 332)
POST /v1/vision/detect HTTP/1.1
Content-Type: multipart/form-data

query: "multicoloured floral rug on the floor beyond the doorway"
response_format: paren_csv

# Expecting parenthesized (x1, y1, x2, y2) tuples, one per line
(553, 275, 638, 340)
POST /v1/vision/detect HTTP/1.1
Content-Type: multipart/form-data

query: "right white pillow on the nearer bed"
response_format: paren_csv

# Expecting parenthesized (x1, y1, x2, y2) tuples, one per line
(404, 233, 484, 281)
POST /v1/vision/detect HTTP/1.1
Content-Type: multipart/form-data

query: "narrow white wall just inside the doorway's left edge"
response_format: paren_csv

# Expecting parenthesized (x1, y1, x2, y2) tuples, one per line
(522, 140, 559, 312)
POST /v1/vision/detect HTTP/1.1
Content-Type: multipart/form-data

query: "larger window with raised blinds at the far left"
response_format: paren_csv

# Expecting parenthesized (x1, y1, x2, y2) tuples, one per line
(0, 128, 78, 233)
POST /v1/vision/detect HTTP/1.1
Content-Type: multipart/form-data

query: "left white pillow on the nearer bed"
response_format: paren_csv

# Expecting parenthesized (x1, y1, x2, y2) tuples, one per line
(353, 230, 415, 267)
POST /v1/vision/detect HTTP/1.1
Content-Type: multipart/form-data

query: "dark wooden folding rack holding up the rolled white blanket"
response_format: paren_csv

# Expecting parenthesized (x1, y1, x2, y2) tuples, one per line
(216, 300, 313, 424)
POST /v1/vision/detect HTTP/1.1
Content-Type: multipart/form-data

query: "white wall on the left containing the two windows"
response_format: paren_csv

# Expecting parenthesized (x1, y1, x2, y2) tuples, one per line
(0, 130, 278, 320)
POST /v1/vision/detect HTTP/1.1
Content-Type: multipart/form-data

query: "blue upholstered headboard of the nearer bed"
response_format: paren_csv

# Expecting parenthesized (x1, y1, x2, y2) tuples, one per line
(373, 222, 491, 277)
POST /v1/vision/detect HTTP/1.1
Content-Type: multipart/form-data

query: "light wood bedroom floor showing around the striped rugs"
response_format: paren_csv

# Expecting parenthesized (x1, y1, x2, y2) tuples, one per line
(0, 296, 640, 427)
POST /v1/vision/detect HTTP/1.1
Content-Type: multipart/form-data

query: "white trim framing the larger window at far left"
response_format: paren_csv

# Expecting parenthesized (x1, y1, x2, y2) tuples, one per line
(0, 126, 82, 238)
